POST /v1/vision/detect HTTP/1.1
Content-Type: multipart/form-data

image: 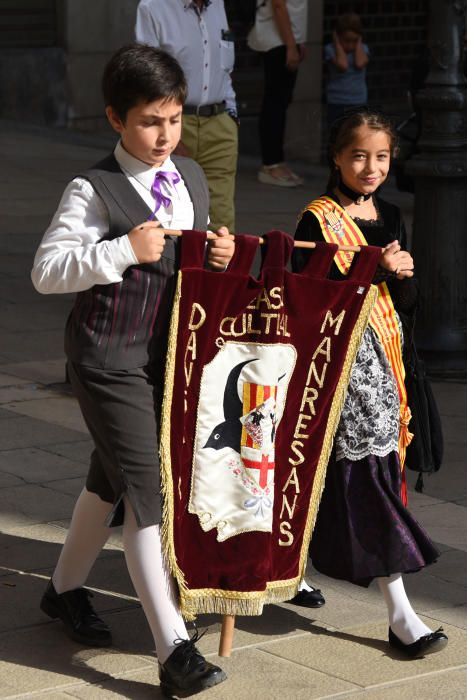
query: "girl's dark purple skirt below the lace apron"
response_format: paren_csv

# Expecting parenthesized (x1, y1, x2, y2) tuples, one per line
(310, 452, 439, 586)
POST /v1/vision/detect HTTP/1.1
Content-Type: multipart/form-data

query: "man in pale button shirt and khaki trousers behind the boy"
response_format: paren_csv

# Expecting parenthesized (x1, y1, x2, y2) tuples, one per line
(135, 0, 238, 231)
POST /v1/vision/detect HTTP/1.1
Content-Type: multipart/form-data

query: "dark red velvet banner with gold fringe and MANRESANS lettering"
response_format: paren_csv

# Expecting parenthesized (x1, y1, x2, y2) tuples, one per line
(161, 231, 381, 618)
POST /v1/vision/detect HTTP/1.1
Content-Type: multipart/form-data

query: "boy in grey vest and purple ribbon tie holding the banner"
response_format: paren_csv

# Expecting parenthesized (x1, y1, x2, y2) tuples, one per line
(32, 44, 233, 693)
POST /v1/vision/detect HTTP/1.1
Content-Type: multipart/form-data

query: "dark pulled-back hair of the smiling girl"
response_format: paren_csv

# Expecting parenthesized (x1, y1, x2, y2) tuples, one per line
(327, 105, 397, 189)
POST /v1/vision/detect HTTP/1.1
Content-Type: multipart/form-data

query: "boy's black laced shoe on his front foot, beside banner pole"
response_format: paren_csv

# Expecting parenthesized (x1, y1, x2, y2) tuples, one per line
(159, 632, 227, 697)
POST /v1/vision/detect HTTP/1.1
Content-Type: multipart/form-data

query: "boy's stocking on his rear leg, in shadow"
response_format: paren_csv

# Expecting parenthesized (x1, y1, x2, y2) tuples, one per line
(52, 489, 112, 593)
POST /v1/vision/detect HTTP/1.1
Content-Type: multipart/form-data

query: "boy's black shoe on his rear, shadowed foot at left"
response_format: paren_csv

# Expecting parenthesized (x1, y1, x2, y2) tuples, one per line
(41, 580, 112, 647)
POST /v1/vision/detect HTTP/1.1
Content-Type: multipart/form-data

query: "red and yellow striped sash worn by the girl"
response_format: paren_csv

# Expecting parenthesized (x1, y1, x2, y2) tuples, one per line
(302, 197, 413, 503)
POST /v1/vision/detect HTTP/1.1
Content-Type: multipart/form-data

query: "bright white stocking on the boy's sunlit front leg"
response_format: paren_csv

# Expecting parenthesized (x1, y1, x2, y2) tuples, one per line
(123, 499, 188, 663)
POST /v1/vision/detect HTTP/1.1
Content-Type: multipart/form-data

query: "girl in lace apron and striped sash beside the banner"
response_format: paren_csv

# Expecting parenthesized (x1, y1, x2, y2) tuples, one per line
(293, 108, 447, 657)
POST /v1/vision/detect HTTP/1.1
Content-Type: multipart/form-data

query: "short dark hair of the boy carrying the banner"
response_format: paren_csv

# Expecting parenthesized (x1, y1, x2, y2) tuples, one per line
(102, 43, 187, 121)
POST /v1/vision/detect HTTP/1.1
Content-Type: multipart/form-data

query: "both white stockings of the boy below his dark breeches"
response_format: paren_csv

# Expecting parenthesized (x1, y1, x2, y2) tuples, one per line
(52, 489, 188, 663)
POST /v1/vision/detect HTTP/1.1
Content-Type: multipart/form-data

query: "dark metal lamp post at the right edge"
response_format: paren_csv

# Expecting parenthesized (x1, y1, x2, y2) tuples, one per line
(407, 0, 467, 376)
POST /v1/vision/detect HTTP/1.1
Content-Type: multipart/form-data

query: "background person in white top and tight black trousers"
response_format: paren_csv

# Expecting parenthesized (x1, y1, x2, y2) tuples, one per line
(248, 0, 308, 187)
